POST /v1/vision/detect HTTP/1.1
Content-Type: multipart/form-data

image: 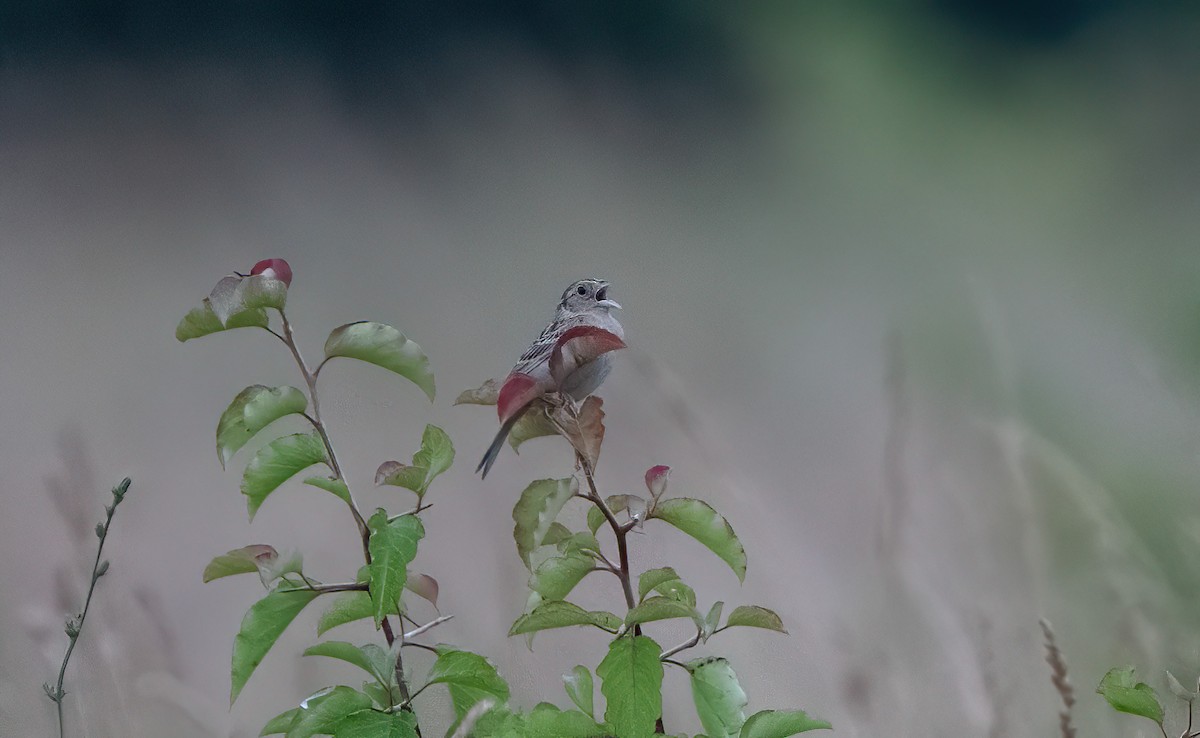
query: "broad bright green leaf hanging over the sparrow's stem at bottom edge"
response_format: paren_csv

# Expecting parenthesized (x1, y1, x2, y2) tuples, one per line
(596, 636, 662, 738)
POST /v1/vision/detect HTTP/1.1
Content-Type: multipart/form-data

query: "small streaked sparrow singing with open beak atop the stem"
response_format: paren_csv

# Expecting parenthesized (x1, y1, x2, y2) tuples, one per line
(475, 280, 625, 478)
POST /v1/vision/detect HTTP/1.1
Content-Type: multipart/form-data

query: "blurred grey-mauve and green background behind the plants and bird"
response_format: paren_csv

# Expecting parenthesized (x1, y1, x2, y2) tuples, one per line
(0, 0, 1200, 738)
